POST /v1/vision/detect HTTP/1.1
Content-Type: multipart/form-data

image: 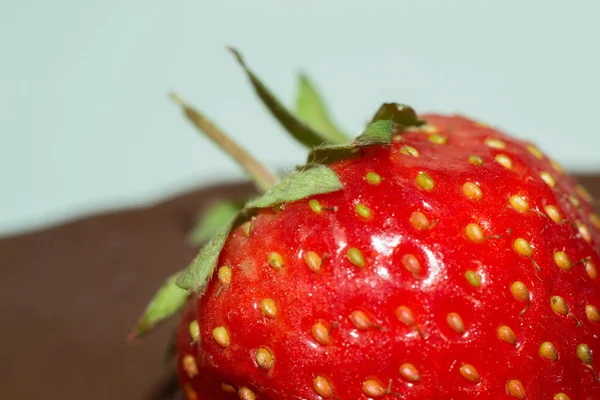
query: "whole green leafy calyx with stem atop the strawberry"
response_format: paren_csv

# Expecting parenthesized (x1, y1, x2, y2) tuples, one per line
(130, 48, 425, 339)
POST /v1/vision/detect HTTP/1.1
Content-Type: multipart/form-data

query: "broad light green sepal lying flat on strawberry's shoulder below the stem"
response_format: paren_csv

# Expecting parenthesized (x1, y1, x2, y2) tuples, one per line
(246, 165, 343, 208)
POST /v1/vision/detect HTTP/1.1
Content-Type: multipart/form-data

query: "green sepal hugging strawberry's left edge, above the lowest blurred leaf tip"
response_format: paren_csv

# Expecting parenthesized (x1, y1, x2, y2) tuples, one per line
(177, 218, 237, 292)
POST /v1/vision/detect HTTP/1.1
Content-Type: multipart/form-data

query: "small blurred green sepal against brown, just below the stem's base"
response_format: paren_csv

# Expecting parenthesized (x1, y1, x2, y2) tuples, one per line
(188, 200, 244, 247)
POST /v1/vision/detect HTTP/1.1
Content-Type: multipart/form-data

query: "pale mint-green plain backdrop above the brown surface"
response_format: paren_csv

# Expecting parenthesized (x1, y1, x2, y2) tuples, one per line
(0, 0, 600, 234)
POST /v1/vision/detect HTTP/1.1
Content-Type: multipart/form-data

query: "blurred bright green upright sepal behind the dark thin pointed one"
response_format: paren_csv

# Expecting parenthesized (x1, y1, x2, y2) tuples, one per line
(296, 74, 350, 143)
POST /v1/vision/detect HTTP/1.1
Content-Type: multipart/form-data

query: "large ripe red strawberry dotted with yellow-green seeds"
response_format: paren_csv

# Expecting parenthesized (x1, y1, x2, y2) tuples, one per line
(131, 50, 600, 400)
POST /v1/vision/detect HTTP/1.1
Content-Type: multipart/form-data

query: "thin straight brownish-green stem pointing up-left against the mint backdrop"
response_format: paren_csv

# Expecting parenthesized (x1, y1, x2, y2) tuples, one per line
(170, 93, 277, 192)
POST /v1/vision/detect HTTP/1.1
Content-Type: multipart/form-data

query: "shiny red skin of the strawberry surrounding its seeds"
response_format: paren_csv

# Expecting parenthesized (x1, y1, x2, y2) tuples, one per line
(178, 115, 600, 400)
